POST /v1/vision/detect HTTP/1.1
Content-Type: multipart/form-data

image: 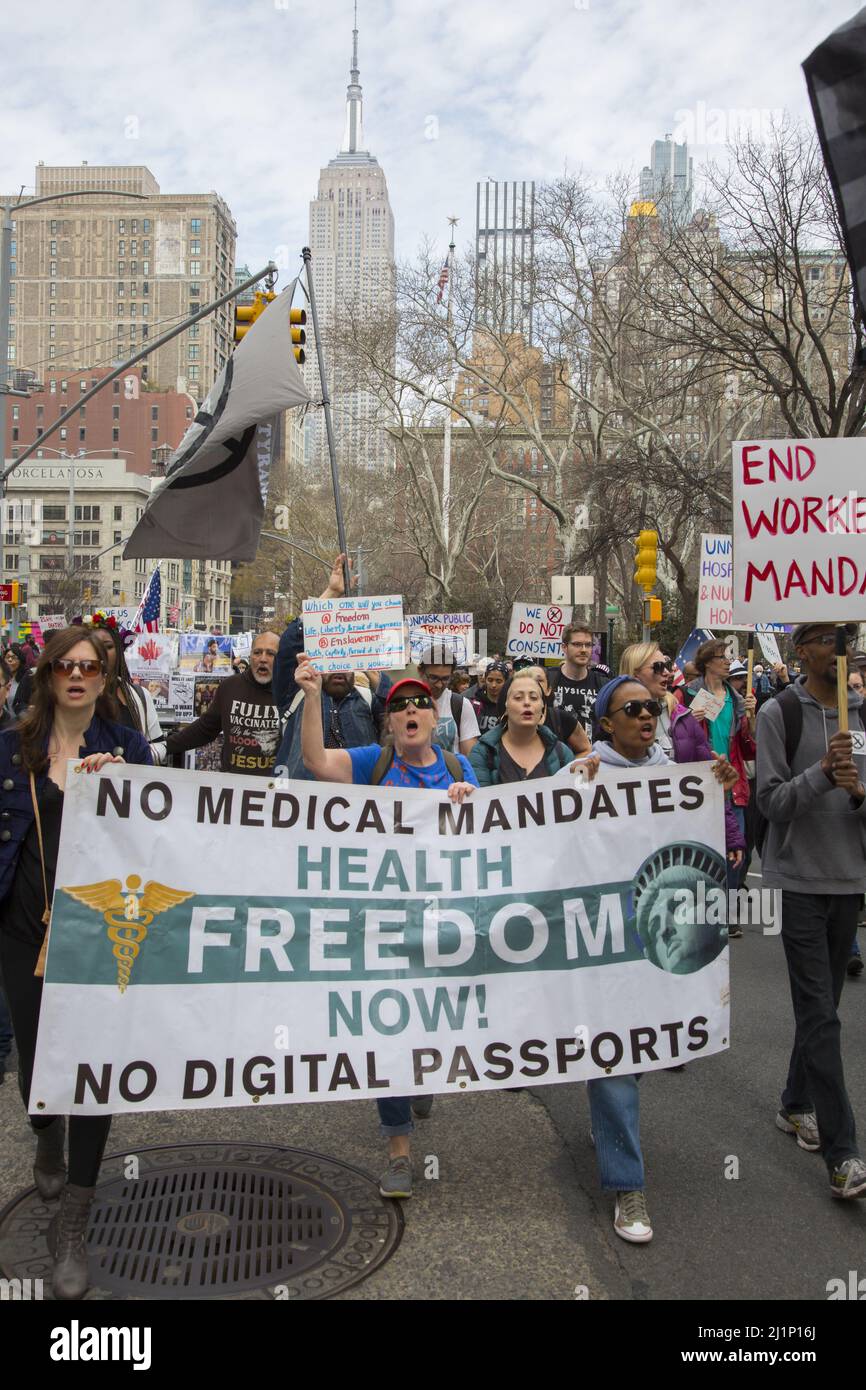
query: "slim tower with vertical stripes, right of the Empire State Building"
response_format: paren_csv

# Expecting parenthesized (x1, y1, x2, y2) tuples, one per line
(475, 179, 535, 343)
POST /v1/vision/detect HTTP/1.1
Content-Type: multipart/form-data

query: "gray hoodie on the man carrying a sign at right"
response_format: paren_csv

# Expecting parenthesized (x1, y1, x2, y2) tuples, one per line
(756, 681, 866, 894)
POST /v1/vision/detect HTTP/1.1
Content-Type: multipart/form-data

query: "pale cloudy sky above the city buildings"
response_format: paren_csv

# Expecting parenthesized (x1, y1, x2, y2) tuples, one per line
(0, 0, 856, 270)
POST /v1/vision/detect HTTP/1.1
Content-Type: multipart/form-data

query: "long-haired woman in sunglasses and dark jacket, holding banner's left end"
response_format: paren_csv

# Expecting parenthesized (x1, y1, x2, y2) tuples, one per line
(0, 627, 152, 1298)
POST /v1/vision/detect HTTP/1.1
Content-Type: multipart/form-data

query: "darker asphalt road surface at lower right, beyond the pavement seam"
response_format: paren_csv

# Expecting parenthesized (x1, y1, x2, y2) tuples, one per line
(534, 880, 866, 1301)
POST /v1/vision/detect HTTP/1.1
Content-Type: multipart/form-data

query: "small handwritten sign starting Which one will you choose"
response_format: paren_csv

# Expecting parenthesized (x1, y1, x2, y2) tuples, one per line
(303, 594, 406, 676)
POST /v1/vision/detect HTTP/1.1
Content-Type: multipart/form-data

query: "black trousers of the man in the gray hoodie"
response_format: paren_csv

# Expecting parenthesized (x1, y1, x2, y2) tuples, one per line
(781, 891, 860, 1168)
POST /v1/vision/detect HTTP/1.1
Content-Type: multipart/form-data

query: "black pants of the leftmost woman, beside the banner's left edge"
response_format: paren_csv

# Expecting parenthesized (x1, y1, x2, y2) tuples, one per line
(0, 931, 111, 1187)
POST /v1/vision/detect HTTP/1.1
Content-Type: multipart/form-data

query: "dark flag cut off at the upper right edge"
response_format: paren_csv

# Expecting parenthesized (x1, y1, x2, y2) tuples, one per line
(803, 8, 866, 318)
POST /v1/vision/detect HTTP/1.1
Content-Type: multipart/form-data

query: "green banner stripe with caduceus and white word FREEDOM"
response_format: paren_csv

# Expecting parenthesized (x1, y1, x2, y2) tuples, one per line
(46, 883, 644, 987)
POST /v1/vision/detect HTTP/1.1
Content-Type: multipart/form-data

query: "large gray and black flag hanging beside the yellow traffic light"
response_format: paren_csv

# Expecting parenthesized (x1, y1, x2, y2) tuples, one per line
(124, 281, 310, 560)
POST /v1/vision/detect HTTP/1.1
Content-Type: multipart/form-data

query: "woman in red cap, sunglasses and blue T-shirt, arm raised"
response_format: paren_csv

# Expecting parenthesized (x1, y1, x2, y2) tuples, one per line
(295, 653, 478, 1198)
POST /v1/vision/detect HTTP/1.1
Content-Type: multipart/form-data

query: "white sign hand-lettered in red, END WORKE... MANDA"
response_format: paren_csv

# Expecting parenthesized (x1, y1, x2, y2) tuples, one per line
(733, 438, 866, 624)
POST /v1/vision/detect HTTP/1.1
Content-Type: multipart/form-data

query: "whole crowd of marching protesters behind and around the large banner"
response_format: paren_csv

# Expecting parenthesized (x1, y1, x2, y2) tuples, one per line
(0, 556, 866, 1298)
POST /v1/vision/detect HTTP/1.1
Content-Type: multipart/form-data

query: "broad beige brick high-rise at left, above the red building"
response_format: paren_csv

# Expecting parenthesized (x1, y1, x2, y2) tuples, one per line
(2, 163, 235, 400)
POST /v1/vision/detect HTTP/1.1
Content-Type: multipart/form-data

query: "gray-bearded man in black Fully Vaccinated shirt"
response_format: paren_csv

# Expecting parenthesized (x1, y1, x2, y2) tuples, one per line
(165, 632, 281, 777)
